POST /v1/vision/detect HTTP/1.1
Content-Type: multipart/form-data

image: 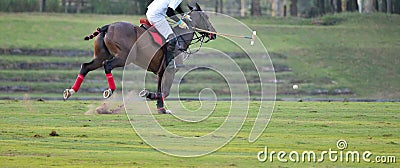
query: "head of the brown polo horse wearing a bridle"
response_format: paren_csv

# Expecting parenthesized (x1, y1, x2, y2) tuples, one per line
(188, 3, 217, 40)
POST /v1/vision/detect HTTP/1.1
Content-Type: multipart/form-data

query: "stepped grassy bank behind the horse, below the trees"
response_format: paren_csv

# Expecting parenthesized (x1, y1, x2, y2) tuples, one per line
(0, 13, 400, 100)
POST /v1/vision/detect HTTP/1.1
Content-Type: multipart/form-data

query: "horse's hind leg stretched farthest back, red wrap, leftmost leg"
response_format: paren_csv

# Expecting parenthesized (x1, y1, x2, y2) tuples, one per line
(63, 58, 103, 100)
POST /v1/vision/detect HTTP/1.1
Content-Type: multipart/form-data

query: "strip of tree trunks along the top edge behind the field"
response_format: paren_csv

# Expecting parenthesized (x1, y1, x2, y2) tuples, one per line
(0, 0, 400, 17)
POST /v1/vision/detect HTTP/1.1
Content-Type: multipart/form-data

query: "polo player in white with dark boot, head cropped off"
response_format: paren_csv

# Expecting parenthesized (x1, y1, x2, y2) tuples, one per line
(146, 0, 189, 68)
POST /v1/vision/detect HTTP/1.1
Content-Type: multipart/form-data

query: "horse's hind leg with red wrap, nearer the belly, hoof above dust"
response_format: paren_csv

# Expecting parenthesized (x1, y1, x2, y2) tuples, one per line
(103, 57, 126, 98)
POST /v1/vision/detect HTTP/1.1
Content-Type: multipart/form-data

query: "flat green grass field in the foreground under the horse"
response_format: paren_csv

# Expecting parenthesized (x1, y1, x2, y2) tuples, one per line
(0, 100, 400, 167)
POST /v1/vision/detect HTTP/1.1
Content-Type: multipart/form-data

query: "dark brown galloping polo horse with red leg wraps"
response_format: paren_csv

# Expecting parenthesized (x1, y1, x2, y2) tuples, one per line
(63, 3, 216, 114)
